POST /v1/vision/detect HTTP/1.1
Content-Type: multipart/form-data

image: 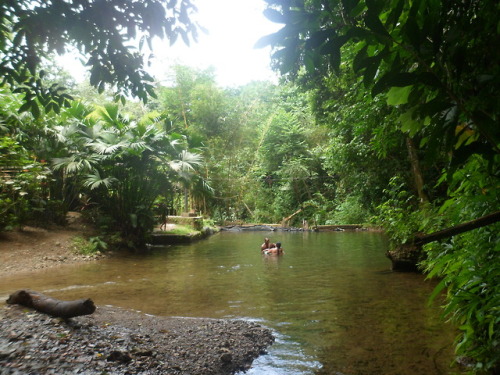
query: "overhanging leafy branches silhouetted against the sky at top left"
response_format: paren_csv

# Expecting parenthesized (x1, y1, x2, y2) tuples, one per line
(0, 0, 198, 116)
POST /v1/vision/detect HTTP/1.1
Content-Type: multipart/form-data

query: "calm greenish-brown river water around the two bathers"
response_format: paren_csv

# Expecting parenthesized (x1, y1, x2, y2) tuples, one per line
(0, 232, 458, 375)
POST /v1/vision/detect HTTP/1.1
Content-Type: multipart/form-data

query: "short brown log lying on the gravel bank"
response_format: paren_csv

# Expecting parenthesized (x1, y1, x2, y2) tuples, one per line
(7, 289, 96, 319)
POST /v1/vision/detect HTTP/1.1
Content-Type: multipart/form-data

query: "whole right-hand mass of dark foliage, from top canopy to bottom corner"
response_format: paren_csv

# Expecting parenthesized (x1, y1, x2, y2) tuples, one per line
(259, 0, 500, 373)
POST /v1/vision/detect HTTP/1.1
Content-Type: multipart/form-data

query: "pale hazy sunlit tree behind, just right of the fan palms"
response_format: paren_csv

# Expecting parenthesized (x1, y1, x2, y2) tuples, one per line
(149, 65, 254, 220)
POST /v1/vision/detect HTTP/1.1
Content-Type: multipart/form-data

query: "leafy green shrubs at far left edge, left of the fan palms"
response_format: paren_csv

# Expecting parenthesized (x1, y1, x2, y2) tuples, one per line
(0, 88, 65, 229)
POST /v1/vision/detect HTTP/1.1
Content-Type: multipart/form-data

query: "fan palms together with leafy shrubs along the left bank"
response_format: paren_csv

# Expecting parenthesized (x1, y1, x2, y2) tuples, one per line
(1, 85, 205, 247)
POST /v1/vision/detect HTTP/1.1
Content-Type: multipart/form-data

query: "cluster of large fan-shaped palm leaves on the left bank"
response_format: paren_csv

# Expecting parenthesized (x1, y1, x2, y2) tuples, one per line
(2, 94, 206, 247)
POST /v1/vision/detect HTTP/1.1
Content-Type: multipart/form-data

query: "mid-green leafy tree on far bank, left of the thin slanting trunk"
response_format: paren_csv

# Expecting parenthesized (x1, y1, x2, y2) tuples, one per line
(307, 63, 424, 223)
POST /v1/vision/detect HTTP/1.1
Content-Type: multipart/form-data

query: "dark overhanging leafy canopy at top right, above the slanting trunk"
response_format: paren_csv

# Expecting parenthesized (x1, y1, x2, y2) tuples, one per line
(259, 0, 500, 170)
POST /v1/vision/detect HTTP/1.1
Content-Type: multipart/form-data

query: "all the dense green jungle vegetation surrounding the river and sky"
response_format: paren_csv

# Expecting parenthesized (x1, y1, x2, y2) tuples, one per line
(0, 0, 500, 374)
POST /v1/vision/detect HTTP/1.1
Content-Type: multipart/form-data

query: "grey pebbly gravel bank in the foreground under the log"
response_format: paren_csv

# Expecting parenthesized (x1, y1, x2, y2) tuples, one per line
(0, 305, 274, 375)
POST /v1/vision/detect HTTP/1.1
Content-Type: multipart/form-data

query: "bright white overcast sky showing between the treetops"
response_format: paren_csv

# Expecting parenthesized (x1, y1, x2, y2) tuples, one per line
(62, 0, 282, 87)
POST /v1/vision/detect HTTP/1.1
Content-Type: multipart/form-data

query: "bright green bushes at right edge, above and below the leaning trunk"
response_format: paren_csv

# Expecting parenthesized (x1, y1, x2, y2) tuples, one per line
(424, 155, 500, 373)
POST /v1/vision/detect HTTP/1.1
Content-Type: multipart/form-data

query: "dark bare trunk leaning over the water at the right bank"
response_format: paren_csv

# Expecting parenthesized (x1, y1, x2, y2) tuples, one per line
(386, 211, 500, 271)
